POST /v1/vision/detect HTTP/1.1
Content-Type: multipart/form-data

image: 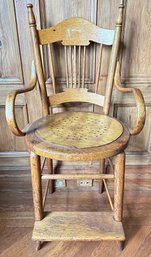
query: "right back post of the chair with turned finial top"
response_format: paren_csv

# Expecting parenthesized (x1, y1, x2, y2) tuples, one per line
(103, 0, 124, 115)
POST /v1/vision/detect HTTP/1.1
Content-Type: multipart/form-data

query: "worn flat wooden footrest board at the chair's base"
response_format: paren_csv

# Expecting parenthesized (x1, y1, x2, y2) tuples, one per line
(32, 212, 125, 241)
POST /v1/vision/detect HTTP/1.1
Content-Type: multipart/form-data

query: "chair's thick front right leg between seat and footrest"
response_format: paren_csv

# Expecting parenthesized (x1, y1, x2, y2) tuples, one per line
(114, 152, 125, 221)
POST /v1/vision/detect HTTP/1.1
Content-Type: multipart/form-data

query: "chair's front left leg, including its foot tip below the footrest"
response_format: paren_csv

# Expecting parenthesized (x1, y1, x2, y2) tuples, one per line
(30, 152, 43, 250)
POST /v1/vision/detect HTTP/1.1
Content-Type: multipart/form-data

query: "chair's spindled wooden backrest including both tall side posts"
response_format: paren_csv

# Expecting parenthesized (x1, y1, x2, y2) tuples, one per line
(27, 1, 124, 115)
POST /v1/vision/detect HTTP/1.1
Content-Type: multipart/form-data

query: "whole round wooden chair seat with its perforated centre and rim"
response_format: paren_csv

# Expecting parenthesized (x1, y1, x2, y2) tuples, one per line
(26, 112, 129, 161)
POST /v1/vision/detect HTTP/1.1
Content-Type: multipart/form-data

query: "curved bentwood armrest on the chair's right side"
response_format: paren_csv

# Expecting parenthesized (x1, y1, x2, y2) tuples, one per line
(114, 61, 146, 135)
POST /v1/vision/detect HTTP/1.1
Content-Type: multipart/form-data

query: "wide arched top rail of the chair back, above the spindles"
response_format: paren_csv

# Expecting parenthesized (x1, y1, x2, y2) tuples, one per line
(38, 18, 114, 46)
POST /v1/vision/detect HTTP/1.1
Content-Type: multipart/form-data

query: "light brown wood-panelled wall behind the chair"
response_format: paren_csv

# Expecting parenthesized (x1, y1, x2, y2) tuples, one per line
(0, 0, 151, 168)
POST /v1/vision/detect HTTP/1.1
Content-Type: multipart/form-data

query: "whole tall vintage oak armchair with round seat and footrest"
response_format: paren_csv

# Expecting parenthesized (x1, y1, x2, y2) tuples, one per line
(6, 1, 145, 249)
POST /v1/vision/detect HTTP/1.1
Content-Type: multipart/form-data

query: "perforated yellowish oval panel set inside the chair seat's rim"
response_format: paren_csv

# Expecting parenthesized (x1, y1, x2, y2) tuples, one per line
(32, 112, 123, 149)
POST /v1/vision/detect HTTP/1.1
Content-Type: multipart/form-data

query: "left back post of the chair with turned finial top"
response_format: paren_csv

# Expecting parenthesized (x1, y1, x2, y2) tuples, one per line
(27, 4, 49, 116)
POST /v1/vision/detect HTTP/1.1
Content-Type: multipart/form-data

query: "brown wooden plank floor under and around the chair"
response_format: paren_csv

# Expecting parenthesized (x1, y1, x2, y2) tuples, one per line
(0, 167, 151, 257)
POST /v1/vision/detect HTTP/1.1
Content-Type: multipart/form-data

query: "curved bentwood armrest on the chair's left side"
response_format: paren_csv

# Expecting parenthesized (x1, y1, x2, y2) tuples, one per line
(5, 61, 37, 136)
